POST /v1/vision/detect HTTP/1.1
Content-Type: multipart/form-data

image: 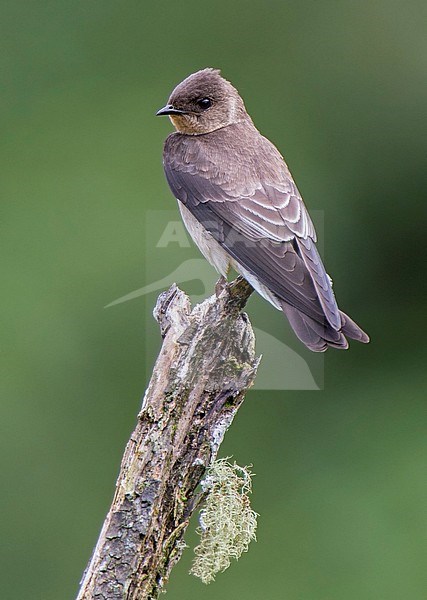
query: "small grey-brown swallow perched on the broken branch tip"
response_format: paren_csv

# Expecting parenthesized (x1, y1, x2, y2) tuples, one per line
(156, 67, 369, 352)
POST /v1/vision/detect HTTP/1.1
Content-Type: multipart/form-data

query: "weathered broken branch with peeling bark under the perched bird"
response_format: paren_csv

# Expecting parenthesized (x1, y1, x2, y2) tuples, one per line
(77, 278, 259, 600)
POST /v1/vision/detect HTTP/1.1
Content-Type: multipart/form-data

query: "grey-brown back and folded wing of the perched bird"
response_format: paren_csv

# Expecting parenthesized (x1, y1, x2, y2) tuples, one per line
(164, 128, 341, 330)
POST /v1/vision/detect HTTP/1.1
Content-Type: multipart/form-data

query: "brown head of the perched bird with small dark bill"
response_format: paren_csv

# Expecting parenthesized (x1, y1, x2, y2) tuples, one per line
(157, 69, 249, 135)
